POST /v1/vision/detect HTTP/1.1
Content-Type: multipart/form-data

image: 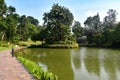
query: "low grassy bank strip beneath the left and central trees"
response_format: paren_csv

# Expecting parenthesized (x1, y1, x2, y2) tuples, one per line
(0, 41, 79, 51)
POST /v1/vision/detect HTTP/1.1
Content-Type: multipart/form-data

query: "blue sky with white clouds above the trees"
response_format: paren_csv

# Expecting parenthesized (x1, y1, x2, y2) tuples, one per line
(5, 0, 120, 26)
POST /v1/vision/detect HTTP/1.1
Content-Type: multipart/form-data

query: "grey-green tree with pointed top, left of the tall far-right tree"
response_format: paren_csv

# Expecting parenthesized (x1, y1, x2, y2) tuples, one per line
(84, 13, 102, 43)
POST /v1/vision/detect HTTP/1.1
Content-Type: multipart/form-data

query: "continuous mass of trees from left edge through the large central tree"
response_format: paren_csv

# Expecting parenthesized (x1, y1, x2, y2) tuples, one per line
(0, 0, 75, 44)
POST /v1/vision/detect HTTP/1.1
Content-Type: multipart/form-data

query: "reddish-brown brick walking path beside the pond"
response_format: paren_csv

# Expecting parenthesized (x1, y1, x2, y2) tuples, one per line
(0, 47, 33, 80)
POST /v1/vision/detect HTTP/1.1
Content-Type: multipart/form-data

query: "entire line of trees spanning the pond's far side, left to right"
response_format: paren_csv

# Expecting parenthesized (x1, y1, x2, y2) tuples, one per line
(0, 0, 120, 46)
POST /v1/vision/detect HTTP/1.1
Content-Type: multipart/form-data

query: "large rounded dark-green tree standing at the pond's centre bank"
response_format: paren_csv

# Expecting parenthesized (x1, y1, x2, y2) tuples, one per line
(43, 4, 73, 44)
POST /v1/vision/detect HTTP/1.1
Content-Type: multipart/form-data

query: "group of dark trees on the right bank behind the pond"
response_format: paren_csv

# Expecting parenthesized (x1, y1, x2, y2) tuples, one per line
(83, 9, 120, 47)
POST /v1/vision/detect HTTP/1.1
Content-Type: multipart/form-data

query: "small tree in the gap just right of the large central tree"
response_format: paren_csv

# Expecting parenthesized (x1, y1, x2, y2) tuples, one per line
(72, 21, 83, 38)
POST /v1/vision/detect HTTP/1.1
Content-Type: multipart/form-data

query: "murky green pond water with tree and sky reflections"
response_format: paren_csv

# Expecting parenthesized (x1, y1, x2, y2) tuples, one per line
(17, 47, 120, 80)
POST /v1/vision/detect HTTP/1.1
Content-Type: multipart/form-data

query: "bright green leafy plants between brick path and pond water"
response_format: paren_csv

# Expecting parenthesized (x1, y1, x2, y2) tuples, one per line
(18, 57, 57, 80)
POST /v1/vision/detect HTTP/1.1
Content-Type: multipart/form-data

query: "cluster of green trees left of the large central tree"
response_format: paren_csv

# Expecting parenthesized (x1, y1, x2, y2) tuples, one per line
(0, 0, 39, 42)
